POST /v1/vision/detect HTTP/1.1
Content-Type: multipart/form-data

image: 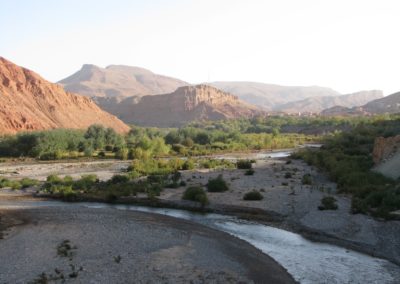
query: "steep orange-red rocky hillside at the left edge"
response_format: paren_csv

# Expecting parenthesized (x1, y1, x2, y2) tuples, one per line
(0, 57, 129, 134)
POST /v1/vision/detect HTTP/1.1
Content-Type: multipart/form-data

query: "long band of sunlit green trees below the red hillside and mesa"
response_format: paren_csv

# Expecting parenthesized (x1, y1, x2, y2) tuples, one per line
(0, 115, 332, 160)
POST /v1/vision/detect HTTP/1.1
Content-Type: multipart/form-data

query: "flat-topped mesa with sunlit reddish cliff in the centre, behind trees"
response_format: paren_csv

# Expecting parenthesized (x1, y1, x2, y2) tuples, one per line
(100, 85, 264, 127)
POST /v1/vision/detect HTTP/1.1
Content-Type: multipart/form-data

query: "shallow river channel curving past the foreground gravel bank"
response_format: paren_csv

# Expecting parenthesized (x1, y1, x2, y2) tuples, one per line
(0, 201, 400, 284)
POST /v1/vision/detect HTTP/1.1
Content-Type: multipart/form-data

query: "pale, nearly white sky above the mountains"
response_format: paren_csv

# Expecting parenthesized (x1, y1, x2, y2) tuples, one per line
(0, 0, 400, 95)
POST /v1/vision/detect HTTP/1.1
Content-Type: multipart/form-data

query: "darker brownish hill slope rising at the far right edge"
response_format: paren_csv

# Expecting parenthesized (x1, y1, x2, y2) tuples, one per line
(321, 92, 400, 116)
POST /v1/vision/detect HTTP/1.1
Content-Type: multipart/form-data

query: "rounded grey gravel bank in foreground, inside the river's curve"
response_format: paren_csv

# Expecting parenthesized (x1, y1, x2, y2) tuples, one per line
(0, 201, 295, 283)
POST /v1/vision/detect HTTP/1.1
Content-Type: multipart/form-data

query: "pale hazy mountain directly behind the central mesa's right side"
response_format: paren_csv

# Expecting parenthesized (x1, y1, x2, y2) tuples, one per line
(207, 82, 341, 111)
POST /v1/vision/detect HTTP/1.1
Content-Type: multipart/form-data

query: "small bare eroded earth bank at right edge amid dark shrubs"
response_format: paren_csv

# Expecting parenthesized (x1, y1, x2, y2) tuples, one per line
(372, 135, 400, 164)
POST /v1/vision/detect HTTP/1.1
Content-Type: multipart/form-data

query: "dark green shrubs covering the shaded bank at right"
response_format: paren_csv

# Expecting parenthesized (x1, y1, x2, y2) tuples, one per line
(294, 116, 400, 218)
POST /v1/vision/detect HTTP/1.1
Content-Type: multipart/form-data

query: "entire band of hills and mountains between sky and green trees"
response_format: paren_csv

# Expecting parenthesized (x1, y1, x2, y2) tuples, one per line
(0, 57, 400, 134)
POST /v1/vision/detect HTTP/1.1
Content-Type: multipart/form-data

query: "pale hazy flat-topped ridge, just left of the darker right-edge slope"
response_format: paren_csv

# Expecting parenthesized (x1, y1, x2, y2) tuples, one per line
(274, 90, 383, 113)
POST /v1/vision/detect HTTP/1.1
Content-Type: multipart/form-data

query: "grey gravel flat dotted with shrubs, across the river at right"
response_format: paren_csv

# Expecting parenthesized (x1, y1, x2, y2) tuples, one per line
(160, 159, 400, 264)
